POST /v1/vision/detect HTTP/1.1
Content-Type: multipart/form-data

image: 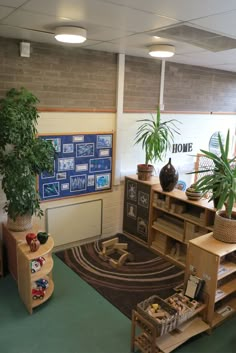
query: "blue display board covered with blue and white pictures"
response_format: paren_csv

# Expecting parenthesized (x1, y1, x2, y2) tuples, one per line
(39, 133, 113, 201)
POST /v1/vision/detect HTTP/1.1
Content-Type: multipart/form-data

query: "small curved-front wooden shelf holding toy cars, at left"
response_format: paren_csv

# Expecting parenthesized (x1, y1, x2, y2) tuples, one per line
(17, 237, 54, 313)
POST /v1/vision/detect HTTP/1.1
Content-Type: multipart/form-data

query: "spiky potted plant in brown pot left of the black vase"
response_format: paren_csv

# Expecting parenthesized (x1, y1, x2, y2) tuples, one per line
(135, 107, 179, 180)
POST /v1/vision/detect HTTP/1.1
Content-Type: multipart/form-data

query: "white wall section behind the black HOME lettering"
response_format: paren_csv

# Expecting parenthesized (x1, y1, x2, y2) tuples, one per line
(121, 113, 236, 185)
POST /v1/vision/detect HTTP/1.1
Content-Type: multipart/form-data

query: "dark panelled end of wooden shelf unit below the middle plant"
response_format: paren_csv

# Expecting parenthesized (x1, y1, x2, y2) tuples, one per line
(123, 175, 159, 245)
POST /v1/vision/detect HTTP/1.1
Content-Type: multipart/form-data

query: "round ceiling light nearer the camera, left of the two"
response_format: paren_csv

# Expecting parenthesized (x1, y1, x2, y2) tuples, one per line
(55, 26, 87, 43)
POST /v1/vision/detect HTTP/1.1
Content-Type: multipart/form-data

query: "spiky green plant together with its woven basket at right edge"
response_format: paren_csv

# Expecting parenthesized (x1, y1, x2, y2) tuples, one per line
(190, 130, 236, 243)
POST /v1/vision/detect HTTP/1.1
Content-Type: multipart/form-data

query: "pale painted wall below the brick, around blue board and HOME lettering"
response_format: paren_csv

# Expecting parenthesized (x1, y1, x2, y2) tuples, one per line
(0, 113, 236, 242)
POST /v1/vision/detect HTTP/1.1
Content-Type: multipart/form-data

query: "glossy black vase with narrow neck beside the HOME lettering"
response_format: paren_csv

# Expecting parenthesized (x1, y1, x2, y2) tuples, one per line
(159, 158, 179, 191)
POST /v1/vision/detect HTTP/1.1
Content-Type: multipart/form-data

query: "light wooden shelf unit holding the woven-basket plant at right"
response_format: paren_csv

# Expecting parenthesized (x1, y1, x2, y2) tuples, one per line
(185, 233, 236, 327)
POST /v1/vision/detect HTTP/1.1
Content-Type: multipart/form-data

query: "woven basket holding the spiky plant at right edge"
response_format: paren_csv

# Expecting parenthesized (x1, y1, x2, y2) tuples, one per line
(213, 211, 236, 243)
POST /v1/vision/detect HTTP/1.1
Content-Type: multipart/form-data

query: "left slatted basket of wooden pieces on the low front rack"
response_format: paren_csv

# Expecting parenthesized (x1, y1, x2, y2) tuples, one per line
(137, 295, 178, 336)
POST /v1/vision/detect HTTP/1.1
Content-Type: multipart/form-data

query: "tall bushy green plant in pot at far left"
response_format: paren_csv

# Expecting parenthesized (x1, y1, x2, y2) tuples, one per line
(0, 88, 55, 231)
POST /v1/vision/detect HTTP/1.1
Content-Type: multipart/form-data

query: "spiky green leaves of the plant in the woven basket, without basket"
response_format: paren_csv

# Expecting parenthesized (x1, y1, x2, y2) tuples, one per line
(188, 130, 236, 218)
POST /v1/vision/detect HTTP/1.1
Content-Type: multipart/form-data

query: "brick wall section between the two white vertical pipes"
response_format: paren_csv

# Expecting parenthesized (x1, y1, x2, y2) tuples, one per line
(124, 56, 161, 111)
